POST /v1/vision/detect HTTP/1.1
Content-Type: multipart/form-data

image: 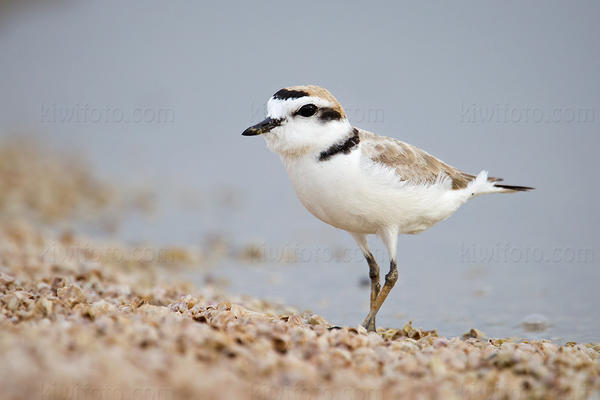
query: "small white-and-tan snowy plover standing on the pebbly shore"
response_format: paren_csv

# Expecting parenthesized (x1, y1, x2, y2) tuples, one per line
(242, 85, 532, 331)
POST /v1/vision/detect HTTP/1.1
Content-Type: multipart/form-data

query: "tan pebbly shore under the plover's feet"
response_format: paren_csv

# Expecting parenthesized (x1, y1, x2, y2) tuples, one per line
(0, 139, 600, 399)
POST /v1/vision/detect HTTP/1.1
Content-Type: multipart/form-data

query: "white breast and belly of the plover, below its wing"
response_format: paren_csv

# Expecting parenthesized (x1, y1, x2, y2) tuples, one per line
(284, 151, 466, 234)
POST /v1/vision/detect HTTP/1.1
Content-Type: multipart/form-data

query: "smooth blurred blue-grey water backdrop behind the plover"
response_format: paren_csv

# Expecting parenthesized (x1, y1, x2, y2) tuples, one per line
(0, 1, 600, 341)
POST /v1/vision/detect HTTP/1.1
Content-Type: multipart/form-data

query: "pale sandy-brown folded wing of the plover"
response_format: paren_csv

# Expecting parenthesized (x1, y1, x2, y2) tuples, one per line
(359, 129, 502, 190)
